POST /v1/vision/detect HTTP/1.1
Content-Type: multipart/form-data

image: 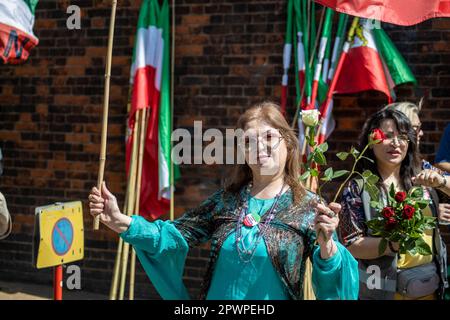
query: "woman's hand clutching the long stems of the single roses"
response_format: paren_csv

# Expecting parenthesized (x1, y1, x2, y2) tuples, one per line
(314, 202, 341, 259)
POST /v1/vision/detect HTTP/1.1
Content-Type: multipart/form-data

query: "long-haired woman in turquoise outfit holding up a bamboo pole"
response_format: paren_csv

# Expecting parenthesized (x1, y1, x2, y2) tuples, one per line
(89, 102, 358, 300)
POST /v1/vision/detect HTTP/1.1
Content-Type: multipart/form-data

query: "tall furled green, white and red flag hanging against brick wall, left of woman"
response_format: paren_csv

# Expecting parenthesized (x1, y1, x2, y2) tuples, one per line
(126, 0, 178, 219)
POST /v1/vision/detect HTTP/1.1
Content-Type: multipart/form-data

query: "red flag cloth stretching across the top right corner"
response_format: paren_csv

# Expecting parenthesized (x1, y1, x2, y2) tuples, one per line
(314, 0, 450, 26)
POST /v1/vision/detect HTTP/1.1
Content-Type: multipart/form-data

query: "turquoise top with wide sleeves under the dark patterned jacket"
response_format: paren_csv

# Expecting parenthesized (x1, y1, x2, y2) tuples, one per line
(120, 192, 346, 300)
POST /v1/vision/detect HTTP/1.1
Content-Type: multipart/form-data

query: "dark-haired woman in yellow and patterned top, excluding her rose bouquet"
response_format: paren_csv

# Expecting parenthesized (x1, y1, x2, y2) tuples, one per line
(339, 108, 448, 300)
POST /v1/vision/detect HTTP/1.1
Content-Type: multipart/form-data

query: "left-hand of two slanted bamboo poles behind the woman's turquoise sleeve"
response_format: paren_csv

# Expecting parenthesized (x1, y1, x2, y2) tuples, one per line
(119, 110, 141, 300)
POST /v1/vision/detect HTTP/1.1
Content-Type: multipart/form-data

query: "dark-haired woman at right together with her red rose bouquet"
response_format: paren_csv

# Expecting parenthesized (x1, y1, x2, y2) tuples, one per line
(339, 109, 446, 300)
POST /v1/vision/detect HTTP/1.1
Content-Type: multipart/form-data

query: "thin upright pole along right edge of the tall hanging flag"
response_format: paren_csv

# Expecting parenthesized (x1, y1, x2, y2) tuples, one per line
(170, 0, 175, 221)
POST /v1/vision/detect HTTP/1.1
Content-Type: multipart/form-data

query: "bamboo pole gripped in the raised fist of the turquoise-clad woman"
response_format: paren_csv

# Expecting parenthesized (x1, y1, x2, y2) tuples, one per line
(93, 0, 117, 230)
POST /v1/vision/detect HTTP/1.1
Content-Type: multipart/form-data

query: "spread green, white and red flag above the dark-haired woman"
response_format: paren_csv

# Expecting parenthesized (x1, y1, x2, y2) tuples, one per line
(334, 19, 416, 102)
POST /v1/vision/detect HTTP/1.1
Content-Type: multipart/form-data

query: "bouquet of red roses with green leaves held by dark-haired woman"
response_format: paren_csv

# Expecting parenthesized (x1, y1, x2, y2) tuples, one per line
(367, 184, 436, 255)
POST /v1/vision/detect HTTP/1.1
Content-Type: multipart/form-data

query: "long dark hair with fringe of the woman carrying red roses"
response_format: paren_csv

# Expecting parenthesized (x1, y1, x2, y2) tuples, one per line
(358, 108, 420, 190)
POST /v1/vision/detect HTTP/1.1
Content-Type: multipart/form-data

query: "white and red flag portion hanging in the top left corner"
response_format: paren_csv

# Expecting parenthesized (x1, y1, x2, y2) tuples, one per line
(0, 0, 39, 64)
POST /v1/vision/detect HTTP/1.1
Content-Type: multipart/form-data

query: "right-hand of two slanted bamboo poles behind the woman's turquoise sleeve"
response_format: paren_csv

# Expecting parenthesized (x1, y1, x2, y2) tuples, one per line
(129, 109, 147, 300)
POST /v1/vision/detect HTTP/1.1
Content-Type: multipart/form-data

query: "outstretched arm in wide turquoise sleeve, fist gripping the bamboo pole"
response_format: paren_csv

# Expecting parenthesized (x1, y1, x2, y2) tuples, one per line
(89, 184, 221, 300)
